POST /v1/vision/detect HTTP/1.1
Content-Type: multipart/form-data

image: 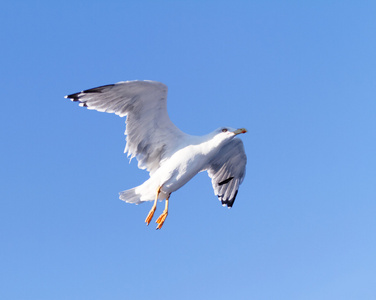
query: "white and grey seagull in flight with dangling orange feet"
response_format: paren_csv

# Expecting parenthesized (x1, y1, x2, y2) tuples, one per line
(65, 80, 247, 229)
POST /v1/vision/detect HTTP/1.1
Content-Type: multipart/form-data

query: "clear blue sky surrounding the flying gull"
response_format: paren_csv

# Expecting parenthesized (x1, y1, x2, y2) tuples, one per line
(0, 0, 376, 300)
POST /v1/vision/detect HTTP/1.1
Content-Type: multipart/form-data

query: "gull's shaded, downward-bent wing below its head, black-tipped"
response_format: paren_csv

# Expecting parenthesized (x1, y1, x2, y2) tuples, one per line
(207, 138, 247, 207)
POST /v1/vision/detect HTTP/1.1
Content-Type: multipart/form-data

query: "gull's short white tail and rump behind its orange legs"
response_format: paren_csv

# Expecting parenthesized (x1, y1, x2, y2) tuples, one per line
(119, 179, 162, 204)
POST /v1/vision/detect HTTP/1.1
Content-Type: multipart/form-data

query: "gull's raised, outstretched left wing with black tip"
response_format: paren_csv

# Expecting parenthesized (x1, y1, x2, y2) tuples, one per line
(65, 80, 187, 173)
